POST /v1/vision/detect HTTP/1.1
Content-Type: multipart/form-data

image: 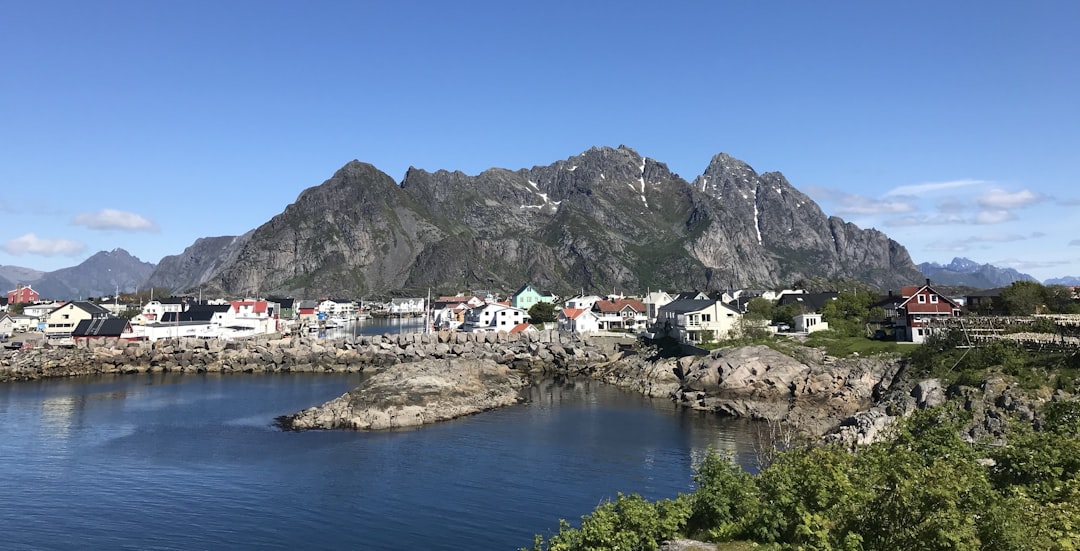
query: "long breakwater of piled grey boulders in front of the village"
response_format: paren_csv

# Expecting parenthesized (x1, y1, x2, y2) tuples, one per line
(0, 331, 616, 382)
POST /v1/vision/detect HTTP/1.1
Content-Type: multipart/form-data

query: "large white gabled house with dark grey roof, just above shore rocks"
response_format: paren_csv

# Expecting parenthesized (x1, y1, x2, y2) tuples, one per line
(653, 299, 742, 344)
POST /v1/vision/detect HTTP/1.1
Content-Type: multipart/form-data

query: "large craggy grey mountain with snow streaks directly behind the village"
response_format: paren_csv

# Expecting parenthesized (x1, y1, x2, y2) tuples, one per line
(150, 146, 922, 296)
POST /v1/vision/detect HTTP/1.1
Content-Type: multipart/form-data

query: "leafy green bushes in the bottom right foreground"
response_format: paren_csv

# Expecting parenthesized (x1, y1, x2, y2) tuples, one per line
(532, 402, 1080, 551)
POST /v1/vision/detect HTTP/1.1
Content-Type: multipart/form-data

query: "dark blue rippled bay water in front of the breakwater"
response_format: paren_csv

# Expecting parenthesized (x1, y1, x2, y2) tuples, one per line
(0, 374, 753, 550)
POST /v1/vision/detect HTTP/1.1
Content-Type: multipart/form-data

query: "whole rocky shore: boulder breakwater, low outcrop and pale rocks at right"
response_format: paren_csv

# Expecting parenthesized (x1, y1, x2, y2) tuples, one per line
(0, 332, 1049, 445)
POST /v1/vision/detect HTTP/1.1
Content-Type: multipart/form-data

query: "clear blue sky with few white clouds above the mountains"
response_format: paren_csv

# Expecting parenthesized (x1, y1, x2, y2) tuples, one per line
(0, 0, 1080, 279)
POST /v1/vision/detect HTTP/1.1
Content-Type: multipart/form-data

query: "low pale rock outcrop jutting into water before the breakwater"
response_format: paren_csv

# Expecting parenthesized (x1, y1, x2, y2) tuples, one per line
(278, 360, 528, 430)
